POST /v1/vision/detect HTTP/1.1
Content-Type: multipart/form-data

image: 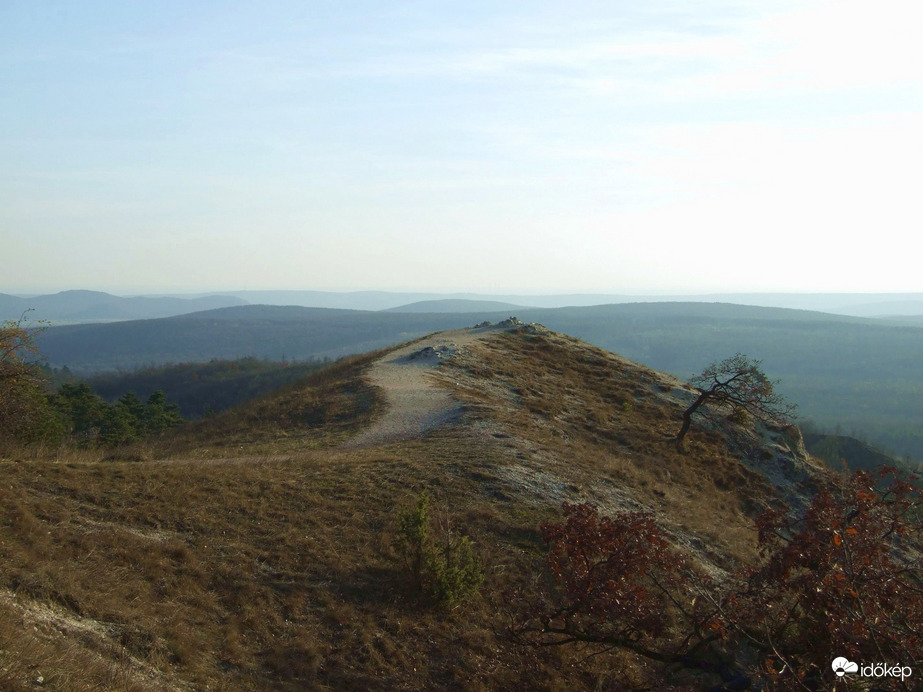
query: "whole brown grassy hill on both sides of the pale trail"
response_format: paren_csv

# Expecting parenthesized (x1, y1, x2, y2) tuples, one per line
(0, 332, 832, 690)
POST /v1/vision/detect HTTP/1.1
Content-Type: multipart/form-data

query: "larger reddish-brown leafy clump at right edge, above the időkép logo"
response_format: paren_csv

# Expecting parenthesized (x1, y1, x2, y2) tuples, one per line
(740, 470, 923, 688)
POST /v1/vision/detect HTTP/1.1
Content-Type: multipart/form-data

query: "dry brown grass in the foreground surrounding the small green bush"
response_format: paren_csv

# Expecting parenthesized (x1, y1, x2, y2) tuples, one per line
(0, 437, 582, 690)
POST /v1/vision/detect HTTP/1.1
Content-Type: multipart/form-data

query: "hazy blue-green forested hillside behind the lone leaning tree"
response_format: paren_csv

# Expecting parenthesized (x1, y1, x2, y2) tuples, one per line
(520, 303, 923, 459)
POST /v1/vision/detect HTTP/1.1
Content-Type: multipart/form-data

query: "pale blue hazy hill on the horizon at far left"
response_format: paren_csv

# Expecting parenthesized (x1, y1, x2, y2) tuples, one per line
(0, 291, 246, 324)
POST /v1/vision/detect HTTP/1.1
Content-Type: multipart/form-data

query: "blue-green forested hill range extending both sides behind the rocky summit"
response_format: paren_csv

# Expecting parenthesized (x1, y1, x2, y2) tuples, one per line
(39, 303, 923, 460)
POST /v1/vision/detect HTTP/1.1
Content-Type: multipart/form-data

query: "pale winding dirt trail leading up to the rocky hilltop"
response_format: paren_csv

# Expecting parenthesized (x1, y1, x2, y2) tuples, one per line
(344, 326, 505, 447)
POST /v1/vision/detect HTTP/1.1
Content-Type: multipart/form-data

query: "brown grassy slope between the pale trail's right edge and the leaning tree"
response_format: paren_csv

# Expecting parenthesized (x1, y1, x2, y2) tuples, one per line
(440, 328, 823, 567)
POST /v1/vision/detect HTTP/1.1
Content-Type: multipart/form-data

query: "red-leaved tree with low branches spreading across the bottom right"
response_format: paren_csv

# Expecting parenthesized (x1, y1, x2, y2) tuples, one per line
(511, 470, 923, 690)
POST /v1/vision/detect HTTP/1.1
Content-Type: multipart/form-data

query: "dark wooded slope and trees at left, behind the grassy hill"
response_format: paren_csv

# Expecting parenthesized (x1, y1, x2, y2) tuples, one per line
(0, 321, 338, 447)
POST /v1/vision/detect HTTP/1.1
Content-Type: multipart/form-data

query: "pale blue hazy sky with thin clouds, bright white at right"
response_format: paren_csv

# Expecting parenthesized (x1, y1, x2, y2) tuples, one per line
(0, 0, 923, 294)
